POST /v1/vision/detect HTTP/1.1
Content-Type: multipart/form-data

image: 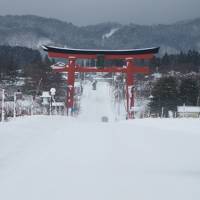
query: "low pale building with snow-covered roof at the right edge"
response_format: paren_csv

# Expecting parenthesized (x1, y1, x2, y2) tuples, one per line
(177, 106, 200, 118)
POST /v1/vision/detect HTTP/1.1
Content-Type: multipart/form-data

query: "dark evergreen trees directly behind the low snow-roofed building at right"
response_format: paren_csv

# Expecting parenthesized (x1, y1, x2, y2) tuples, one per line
(149, 76, 200, 117)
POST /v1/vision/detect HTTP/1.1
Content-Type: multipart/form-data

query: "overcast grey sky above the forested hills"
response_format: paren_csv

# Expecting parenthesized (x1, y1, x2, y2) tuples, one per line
(0, 0, 200, 25)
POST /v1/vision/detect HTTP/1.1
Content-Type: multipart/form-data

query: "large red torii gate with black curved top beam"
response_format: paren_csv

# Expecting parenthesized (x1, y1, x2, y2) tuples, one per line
(42, 46, 159, 118)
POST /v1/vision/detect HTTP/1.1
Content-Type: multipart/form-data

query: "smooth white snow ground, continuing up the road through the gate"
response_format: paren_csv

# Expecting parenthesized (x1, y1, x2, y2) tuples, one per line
(0, 80, 200, 200)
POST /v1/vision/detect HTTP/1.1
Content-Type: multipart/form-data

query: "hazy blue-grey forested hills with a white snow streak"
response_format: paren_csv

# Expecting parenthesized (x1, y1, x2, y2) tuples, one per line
(0, 15, 200, 54)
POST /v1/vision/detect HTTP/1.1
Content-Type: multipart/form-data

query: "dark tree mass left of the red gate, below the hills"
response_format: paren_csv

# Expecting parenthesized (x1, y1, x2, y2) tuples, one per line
(0, 46, 66, 98)
